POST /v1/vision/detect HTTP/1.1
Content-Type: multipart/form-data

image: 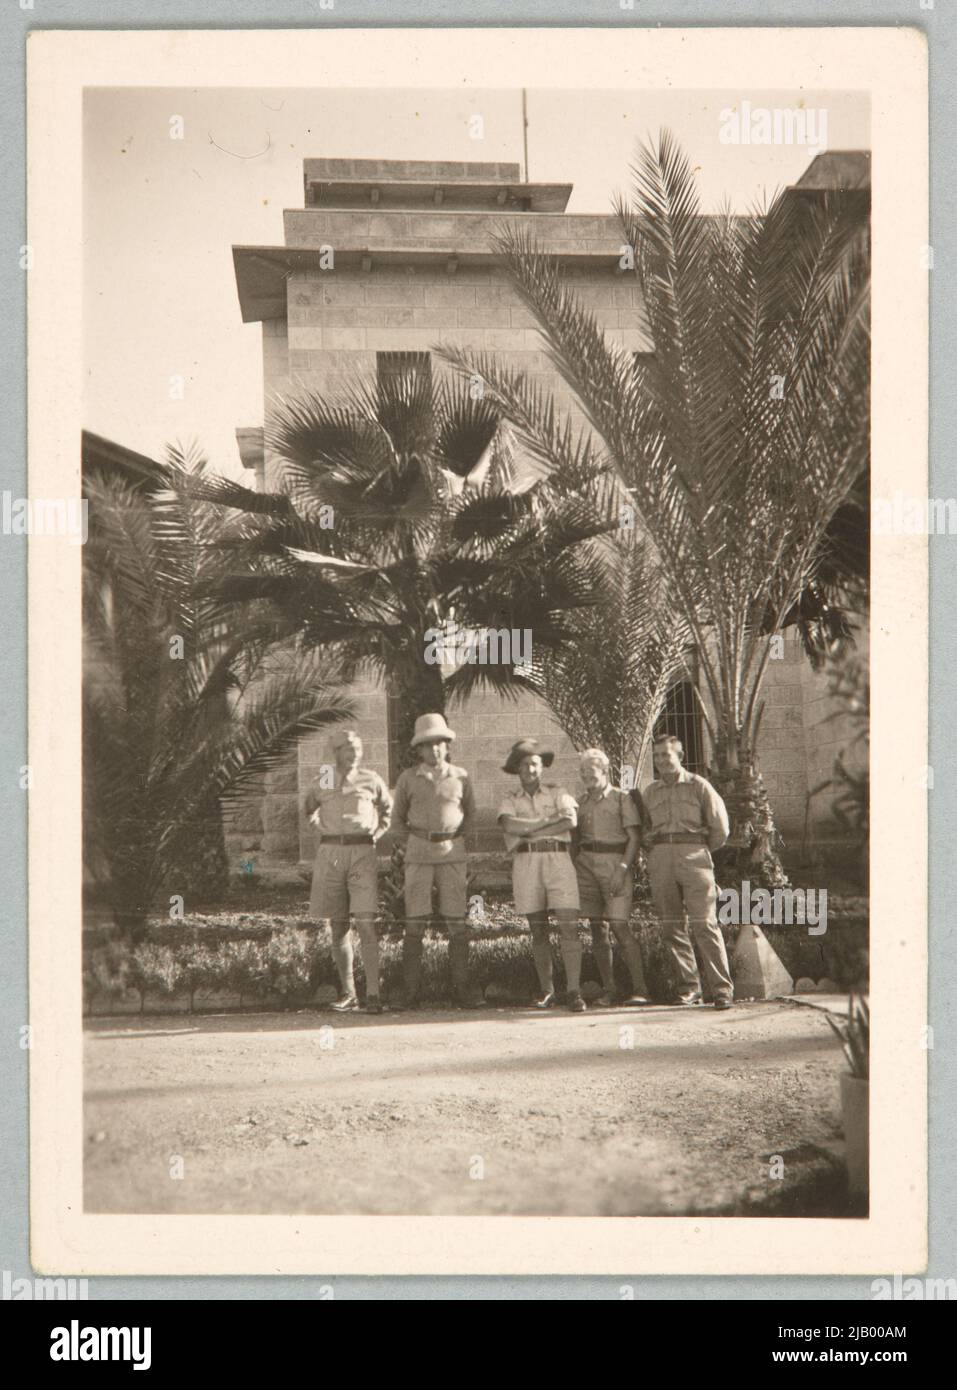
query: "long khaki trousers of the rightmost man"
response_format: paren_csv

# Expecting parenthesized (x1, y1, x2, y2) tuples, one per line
(648, 844, 734, 999)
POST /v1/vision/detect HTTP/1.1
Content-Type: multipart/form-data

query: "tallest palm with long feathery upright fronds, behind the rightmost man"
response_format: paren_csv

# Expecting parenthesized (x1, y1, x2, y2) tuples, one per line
(436, 132, 869, 884)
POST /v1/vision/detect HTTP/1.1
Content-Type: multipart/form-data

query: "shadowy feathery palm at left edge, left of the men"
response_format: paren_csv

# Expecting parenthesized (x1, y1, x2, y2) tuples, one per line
(83, 450, 352, 931)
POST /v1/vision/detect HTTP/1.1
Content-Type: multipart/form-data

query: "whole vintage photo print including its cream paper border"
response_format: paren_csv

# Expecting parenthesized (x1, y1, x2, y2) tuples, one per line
(24, 31, 933, 1278)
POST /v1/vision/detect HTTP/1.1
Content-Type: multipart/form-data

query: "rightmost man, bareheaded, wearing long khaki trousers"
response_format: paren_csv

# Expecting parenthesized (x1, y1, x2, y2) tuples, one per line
(643, 734, 734, 1009)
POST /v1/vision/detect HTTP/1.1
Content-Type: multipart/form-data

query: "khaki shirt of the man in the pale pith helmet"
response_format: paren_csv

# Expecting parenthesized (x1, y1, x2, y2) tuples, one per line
(392, 763, 476, 865)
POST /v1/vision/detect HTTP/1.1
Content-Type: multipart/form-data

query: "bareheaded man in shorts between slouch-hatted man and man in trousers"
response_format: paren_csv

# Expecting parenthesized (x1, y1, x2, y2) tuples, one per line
(574, 748, 648, 1005)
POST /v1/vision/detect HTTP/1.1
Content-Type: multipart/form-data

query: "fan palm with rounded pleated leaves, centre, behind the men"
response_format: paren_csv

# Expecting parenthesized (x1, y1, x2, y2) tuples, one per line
(203, 358, 612, 748)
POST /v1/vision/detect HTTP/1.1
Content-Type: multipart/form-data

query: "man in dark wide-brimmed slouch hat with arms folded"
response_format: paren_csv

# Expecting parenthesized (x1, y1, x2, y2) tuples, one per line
(498, 738, 584, 1013)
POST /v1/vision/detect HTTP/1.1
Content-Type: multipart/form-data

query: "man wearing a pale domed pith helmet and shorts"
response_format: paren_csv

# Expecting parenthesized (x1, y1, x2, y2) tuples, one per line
(392, 714, 481, 1008)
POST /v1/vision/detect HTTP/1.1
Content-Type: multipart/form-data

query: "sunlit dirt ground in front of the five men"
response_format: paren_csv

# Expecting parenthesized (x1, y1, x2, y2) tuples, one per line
(85, 1002, 850, 1216)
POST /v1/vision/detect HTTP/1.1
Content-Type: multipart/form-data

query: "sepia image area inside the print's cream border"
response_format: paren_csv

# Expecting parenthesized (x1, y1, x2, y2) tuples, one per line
(82, 88, 871, 1218)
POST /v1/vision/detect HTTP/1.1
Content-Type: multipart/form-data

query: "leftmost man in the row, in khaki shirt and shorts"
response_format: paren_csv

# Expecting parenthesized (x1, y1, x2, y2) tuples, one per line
(306, 730, 392, 1013)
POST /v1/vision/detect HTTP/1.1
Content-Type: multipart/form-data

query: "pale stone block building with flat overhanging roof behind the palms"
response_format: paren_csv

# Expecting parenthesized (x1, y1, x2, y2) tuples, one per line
(230, 154, 868, 870)
